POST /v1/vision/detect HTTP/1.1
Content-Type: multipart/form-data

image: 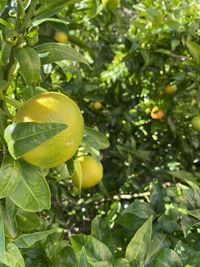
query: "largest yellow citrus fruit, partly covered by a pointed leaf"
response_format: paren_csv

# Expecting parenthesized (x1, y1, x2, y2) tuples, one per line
(14, 92, 84, 168)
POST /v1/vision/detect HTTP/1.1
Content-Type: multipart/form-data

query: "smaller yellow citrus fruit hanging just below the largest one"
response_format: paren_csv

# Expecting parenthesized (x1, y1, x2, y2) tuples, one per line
(72, 156, 103, 188)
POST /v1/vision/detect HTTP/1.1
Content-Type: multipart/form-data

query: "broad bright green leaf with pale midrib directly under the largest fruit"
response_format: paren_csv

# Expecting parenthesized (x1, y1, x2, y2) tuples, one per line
(9, 161, 51, 212)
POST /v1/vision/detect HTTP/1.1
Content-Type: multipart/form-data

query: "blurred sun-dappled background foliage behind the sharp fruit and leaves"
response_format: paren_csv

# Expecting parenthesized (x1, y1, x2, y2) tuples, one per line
(35, 0, 200, 232)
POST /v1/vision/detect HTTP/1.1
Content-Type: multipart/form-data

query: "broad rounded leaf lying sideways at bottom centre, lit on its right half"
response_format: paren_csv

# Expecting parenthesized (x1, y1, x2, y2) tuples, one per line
(71, 234, 112, 261)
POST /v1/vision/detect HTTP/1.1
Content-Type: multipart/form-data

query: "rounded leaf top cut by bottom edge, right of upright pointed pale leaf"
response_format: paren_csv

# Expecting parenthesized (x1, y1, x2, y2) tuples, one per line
(153, 248, 183, 267)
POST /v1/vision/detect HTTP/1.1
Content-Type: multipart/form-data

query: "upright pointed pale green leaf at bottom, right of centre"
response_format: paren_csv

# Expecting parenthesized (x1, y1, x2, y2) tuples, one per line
(125, 216, 153, 263)
